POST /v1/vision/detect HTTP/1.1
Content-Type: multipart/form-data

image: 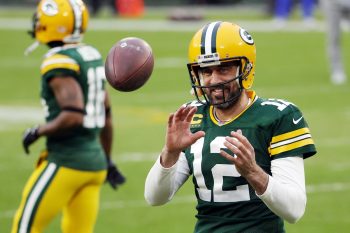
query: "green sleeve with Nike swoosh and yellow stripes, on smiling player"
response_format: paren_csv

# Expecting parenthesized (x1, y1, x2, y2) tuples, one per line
(268, 104, 316, 159)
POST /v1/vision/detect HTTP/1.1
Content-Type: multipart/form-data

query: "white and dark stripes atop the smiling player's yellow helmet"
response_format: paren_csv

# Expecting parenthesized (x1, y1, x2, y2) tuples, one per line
(201, 22, 221, 54)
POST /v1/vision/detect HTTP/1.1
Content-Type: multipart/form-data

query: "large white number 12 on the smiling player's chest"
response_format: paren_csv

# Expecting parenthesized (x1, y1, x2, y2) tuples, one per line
(191, 137, 250, 202)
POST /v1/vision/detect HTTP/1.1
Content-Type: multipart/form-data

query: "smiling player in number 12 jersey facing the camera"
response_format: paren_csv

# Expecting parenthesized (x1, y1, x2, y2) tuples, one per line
(145, 22, 316, 233)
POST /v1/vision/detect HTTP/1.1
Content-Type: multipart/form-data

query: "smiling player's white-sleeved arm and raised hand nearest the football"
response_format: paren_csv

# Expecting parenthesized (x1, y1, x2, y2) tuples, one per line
(144, 106, 205, 205)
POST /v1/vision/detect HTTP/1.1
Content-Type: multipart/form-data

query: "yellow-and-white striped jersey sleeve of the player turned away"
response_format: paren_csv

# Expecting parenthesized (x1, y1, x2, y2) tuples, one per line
(40, 54, 80, 81)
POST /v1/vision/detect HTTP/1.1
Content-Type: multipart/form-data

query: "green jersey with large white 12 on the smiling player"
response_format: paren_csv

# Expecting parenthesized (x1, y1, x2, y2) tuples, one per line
(185, 91, 316, 233)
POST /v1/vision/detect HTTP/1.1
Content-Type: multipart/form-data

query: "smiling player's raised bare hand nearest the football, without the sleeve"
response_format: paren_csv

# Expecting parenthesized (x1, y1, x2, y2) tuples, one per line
(162, 106, 205, 166)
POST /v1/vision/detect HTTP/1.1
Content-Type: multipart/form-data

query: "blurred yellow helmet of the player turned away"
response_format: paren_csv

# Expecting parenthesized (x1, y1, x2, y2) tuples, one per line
(30, 0, 89, 44)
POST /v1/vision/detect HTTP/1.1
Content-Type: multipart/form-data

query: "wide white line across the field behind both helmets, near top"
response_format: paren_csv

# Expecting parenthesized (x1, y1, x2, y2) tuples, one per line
(0, 18, 330, 32)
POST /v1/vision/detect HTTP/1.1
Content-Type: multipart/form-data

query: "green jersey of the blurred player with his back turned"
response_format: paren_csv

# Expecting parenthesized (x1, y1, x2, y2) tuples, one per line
(41, 44, 107, 170)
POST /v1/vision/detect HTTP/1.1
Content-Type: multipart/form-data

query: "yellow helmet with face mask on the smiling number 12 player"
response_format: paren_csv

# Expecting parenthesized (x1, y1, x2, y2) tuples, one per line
(187, 22, 256, 104)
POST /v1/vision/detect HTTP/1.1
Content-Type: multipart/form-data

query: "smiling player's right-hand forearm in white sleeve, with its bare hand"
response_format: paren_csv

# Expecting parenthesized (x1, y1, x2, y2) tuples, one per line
(220, 130, 306, 223)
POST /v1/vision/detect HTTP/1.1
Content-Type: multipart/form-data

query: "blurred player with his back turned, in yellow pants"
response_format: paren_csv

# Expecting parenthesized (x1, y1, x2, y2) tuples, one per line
(12, 0, 125, 233)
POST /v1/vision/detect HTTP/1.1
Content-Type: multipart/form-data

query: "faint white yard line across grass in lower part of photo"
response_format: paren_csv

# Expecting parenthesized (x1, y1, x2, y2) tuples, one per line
(0, 183, 350, 219)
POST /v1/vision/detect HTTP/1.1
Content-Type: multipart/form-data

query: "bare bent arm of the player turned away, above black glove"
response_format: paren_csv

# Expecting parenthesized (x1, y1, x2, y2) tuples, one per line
(38, 77, 85, 136)
